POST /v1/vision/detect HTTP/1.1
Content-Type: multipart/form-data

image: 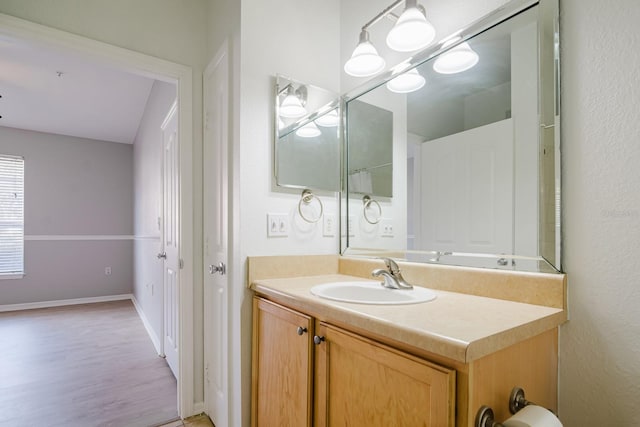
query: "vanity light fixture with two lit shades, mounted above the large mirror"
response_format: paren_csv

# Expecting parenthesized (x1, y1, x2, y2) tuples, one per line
(344, 0, 436, 77)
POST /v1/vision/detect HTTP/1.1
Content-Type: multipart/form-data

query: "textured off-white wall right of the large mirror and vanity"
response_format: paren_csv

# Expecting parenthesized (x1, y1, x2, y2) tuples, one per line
(559, 0, 640, 427)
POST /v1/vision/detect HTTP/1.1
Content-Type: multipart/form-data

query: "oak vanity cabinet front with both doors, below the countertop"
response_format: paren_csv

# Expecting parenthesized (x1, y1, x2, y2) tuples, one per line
(252, 298, 455, 427)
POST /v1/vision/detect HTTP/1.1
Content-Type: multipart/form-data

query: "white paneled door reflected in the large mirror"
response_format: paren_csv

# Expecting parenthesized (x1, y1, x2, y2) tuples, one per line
(420, 119, 514, 254)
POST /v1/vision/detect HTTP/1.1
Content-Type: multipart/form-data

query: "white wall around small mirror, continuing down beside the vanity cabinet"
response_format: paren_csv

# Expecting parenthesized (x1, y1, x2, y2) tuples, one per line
(238, 0, 342, 426)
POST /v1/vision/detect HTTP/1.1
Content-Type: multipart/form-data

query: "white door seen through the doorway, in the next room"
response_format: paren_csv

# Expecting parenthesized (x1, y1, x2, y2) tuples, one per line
(158, 102, 180, 378)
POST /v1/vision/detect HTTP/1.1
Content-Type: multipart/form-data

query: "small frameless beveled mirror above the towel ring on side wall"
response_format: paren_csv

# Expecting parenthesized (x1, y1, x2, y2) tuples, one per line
(274, 76, 340, 191)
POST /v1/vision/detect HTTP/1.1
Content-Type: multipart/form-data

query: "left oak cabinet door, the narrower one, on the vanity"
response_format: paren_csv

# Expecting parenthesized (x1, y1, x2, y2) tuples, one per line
(251, 298, 313, 427)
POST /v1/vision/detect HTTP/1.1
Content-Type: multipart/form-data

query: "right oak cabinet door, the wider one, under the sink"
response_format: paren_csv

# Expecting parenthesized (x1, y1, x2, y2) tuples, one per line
(315, 323, 455, 427)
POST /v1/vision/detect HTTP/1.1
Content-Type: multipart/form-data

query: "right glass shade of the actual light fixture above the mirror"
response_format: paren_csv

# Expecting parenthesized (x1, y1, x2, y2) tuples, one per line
(387, 7, 436, 52)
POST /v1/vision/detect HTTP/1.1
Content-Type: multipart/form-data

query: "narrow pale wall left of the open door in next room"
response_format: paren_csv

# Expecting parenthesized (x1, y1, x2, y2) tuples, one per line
(133, 80, 176, 352)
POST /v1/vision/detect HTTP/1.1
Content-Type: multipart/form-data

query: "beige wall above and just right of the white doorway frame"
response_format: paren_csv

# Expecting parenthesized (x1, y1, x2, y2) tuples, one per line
(0, 0, 209, 408)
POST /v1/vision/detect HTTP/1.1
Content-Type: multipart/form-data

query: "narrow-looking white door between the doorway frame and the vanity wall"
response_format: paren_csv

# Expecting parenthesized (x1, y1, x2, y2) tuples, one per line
(203, 41, 230, 426)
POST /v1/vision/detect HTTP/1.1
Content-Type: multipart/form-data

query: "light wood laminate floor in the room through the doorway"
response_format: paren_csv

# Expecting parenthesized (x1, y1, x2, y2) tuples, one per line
(0, 300, 178, 427)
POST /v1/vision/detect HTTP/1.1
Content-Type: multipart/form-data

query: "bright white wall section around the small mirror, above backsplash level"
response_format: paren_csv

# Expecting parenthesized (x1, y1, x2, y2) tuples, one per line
(240, 0, 340, 255)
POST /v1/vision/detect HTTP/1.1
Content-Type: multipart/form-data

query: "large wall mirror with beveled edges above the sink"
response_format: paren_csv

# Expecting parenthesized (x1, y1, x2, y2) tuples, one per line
(342, 0, 561, 272)
